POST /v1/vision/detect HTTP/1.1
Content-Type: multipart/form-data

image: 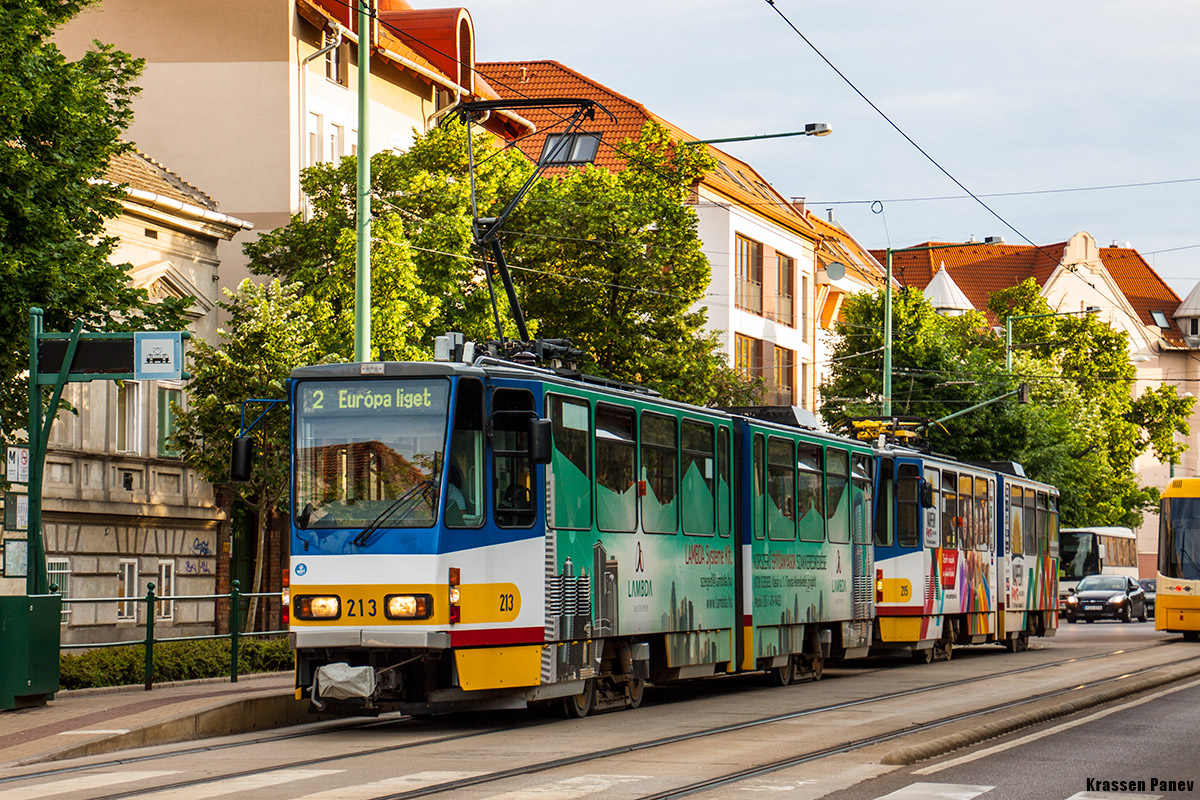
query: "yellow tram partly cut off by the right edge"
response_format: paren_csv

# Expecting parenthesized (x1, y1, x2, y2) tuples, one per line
(1154, 477, 1200, 642)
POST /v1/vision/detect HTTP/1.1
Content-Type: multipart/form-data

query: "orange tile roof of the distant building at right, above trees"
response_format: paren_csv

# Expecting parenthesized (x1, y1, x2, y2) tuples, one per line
(871, 237, 1183, 344)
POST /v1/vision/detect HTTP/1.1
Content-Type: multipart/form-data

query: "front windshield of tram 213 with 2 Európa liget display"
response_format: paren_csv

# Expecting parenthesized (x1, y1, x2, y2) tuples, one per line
(294, 379, 450, 529)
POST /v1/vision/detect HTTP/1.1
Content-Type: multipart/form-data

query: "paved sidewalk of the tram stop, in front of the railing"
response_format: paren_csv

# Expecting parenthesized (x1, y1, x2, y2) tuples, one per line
(0, 672, 307, 768)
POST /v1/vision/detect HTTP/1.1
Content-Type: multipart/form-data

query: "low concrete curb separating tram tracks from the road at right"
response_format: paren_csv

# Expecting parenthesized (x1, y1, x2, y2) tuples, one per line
(880, 663, 1200, 766)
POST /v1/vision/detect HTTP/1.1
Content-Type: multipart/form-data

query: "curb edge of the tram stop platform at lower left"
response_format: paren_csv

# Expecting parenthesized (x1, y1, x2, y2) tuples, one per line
(22, 691, 328, 766)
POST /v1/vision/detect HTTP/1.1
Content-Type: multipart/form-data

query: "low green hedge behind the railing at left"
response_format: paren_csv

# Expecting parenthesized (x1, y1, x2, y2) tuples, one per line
(59, 637, 293, 690)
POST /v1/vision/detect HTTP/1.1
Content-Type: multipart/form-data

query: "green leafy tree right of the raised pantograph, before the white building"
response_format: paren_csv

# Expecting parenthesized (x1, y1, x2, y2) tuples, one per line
(504, 122, 761, 404)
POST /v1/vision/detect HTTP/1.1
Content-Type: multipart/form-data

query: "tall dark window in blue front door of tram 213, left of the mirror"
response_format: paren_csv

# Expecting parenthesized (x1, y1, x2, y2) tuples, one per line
(492, 389, 538, 528)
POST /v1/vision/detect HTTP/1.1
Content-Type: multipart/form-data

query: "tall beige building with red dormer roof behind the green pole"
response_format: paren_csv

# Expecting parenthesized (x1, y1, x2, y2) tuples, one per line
(56, 0, 530, 292)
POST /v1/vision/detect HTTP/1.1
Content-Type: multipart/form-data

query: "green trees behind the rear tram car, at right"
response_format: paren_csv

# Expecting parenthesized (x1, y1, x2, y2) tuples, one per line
(821, 279, 1193, 528)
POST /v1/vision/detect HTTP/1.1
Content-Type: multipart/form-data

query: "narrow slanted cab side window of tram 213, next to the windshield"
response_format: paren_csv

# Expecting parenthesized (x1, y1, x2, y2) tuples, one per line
(445, 378, 485, 528)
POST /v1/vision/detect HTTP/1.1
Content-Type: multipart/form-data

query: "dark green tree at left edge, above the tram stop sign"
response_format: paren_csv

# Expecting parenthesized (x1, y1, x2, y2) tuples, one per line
(0, 0, 190, 438)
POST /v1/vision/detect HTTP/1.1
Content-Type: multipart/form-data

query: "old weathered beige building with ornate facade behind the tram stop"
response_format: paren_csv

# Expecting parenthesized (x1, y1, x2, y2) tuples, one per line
(2, 152, 250, 644)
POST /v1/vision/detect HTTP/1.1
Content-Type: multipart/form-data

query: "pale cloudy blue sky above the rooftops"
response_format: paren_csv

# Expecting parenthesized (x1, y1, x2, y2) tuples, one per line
(465, 0, 1200, 299)
